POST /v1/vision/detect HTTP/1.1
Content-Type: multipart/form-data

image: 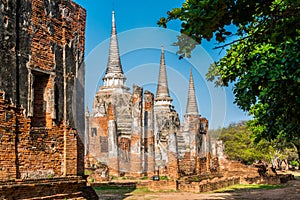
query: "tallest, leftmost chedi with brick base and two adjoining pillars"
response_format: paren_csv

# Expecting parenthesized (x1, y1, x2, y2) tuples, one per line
(86, 13, 154, 176)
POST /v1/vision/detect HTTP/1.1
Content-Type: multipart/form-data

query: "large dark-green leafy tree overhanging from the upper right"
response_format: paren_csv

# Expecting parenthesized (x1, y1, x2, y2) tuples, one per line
(158, 0, 300, 158)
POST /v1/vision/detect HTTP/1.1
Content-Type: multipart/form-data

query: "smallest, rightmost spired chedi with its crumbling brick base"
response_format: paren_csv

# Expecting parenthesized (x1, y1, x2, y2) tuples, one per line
(178, 69, 210, 175)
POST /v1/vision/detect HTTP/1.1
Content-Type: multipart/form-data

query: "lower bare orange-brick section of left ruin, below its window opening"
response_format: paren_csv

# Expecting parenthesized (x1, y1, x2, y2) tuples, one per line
(0, 92, 83, 180)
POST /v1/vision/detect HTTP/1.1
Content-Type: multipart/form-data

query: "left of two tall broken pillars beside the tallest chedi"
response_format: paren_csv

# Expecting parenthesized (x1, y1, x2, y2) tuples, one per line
(130, 85, 143, 176)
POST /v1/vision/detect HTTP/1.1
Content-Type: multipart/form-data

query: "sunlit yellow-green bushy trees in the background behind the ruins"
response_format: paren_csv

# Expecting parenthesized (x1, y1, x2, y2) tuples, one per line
(214, 122, 296, 164)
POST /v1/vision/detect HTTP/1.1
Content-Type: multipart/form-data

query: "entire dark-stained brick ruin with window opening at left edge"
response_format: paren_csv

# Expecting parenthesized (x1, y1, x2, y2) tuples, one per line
(0, 0, 97, 199)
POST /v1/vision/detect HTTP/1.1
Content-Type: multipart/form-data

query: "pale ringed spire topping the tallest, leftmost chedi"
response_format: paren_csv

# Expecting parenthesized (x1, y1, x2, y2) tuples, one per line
(103, 11, 126, 87)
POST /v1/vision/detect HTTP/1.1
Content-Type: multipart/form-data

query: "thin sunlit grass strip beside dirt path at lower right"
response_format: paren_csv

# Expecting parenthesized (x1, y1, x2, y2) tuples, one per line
(212, 184, 286, 193)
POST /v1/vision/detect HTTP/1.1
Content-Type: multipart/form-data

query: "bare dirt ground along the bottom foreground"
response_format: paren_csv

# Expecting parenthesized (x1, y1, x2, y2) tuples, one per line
(99, 173, 300, 200)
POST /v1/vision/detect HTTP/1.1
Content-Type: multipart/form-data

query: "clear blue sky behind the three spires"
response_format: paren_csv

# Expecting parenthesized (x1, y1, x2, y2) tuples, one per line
(74, 0, 249, 128)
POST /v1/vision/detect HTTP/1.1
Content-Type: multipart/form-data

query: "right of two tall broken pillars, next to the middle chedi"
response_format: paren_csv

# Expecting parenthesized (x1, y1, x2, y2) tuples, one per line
(144, 91, 155, 177)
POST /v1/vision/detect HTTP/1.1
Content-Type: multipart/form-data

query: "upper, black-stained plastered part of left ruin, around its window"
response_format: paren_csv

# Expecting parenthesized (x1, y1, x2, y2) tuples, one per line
(0, 0, 86, 127)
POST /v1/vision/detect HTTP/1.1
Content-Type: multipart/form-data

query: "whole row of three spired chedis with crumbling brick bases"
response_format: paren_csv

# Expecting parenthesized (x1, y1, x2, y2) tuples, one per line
(85, 12, 218, 180)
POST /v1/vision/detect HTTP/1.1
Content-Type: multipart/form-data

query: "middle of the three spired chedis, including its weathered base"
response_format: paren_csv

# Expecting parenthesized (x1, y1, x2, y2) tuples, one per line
(154, 47, 180, 178)
